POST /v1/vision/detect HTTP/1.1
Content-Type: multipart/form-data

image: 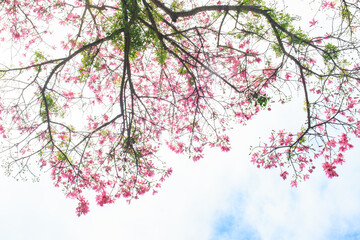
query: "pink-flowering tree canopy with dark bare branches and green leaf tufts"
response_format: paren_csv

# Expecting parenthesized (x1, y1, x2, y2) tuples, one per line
(0, 0, 360, 216)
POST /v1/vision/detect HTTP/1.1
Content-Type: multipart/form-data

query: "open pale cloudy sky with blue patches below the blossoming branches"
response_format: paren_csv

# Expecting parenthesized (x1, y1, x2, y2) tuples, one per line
(0, 1, 360, 240)
